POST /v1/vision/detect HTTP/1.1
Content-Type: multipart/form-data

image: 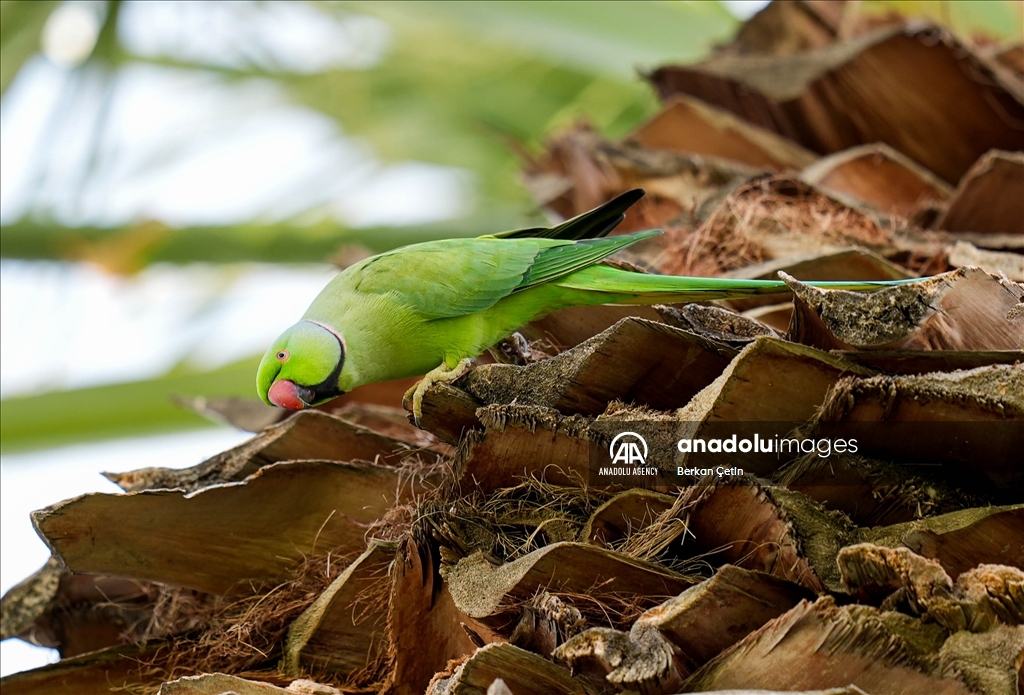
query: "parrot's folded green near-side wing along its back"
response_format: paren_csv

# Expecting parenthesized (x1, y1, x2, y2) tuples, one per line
(348, 230, 660, 320)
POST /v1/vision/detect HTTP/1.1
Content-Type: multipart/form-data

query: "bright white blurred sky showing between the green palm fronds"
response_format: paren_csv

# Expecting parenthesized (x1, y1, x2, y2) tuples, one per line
(0, 0, 766, 675)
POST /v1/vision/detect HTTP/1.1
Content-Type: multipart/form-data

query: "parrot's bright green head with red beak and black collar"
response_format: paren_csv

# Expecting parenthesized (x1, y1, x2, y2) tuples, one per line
(256, 320, 345, 410)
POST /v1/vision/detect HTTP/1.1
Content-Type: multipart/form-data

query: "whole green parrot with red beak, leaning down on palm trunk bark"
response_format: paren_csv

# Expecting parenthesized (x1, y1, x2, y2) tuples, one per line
(256, 188, 902, 425)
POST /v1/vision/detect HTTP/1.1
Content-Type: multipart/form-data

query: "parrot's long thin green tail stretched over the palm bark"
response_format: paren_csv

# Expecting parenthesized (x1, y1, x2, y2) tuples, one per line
(558, 265, 918, 304)
